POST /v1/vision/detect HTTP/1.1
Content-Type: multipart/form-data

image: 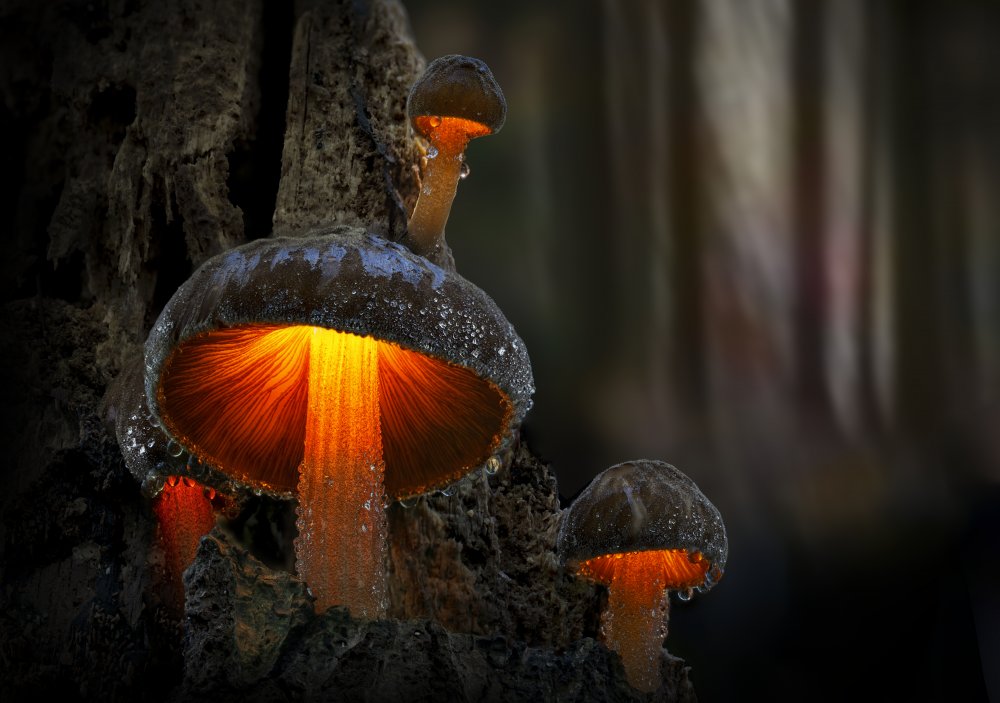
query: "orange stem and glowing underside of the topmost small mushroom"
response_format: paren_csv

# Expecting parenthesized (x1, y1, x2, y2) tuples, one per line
(407, 117, 490, 256)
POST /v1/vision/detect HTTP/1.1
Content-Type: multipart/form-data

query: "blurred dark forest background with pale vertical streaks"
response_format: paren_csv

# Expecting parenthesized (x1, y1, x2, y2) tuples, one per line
(404, 0, 1000, 703)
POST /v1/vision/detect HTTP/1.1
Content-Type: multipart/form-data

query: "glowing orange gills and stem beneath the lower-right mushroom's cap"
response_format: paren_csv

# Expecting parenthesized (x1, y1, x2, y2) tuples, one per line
(579, 549, 708, 693)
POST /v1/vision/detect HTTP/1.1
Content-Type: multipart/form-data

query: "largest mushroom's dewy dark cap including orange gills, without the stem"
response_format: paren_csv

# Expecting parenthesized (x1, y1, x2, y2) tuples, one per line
(144, 227, 534, 498)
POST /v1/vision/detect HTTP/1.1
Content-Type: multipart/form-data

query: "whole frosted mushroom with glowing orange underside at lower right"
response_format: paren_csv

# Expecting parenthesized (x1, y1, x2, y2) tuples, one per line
(558, 459, 729, 692)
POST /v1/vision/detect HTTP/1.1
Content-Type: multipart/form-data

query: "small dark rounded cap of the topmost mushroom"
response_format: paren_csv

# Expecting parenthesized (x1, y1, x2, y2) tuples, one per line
(406, 54, 507, 133)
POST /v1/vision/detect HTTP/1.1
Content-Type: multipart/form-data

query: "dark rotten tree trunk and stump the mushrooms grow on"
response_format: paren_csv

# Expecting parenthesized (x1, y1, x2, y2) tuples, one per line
(0, 0, 694, 703)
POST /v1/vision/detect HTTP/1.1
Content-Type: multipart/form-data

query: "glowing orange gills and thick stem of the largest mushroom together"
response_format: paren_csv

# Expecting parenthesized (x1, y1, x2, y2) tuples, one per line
(159, 325, 513, 619)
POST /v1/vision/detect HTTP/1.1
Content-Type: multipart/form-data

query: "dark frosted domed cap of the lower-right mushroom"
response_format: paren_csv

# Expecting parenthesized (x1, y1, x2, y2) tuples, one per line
(558, 459, 729, 579)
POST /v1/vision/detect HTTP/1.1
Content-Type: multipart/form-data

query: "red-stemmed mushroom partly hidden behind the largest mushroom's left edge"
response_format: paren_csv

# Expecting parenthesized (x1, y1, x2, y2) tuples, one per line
(106, 358, 232, 614)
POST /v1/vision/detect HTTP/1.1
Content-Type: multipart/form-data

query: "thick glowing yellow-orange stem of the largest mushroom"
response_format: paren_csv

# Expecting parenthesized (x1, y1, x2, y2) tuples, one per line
(295, 327, 387, 620)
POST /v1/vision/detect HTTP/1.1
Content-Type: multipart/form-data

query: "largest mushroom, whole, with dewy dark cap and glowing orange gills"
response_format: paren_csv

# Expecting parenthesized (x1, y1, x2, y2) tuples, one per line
(139, 227, 534, 619)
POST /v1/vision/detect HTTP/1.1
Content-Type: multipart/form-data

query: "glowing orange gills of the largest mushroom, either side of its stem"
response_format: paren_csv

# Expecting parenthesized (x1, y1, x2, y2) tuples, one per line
(158, 325, 513, 498)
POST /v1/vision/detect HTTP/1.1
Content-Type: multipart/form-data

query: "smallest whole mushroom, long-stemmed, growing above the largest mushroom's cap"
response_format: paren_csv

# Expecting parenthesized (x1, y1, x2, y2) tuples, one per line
(406, 54, 507, 259)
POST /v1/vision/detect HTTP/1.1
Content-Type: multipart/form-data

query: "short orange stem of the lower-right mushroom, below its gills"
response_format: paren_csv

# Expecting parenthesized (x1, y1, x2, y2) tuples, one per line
(601, 569, 670, 693)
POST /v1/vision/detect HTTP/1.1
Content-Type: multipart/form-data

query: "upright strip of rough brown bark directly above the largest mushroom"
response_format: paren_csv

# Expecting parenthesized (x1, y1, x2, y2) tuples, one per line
(274, 0, 424, 239)
